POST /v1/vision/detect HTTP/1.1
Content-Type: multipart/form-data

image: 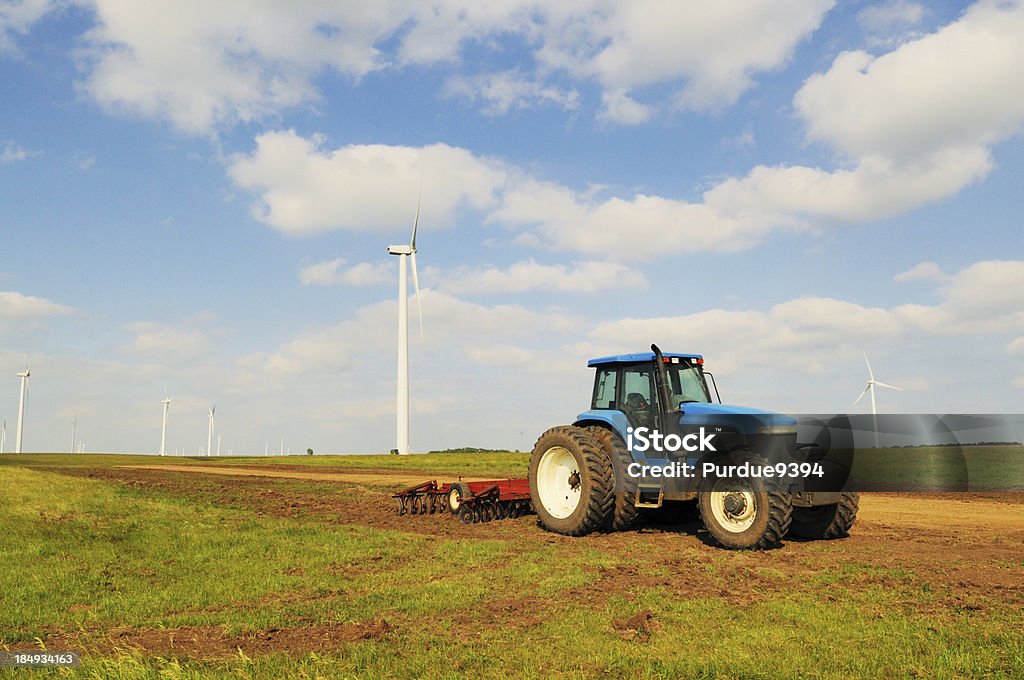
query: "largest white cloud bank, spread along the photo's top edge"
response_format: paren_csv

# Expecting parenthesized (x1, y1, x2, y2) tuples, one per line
(46, 0, 834, 134)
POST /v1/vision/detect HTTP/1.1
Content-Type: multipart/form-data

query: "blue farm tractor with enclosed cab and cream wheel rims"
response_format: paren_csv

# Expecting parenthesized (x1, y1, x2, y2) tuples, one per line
(529, 345, 858, 549)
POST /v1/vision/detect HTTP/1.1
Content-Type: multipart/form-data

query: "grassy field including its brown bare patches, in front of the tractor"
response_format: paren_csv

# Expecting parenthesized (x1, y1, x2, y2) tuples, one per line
(0, 454, 1024, 678)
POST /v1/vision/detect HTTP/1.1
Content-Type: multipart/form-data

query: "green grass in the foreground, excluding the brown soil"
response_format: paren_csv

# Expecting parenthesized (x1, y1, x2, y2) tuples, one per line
(0, 454, 1024, 678)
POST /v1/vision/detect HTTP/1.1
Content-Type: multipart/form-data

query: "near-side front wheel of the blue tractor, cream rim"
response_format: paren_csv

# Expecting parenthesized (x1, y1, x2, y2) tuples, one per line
(697, 453, 793, 550)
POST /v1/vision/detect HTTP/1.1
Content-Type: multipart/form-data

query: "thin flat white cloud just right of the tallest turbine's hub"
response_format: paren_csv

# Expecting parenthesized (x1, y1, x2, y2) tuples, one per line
(434, 260, 647, 296)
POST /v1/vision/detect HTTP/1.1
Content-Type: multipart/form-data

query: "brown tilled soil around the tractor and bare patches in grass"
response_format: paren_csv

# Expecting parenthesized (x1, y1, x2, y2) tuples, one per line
(25, 466, 1024, 657)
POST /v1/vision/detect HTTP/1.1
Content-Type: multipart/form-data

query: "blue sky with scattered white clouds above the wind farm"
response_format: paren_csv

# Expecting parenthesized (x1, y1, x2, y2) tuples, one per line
(0, 0, 1024, 454)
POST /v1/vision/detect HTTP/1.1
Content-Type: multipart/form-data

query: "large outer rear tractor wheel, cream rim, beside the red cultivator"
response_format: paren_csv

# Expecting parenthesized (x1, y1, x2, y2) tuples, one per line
(529, 425, 615, 536)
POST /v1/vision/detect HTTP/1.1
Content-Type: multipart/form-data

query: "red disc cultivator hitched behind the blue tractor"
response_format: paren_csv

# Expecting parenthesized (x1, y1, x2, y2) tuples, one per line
(391, 479, 534, 524)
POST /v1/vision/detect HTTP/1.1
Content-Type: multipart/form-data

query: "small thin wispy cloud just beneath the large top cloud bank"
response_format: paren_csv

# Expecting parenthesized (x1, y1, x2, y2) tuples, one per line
(443, 71, 580, 116)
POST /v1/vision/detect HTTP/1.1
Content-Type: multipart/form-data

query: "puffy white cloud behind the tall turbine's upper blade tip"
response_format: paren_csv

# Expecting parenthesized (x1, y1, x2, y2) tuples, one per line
(228, 130, 505, 235)
